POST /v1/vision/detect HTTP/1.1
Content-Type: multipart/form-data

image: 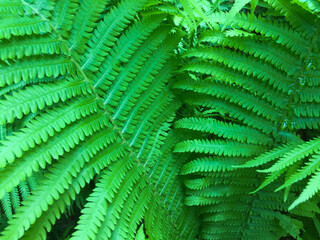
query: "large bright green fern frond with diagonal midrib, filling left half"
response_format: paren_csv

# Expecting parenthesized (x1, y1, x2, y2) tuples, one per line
(0, 0, 198, 239)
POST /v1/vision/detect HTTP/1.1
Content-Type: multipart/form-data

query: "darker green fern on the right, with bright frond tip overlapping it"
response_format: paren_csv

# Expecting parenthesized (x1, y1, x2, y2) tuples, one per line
(174, 0, 320, 239)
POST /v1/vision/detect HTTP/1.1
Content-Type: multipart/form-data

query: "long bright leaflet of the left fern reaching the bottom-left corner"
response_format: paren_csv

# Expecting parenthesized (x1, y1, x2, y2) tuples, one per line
(2, 126, 119, 239)
